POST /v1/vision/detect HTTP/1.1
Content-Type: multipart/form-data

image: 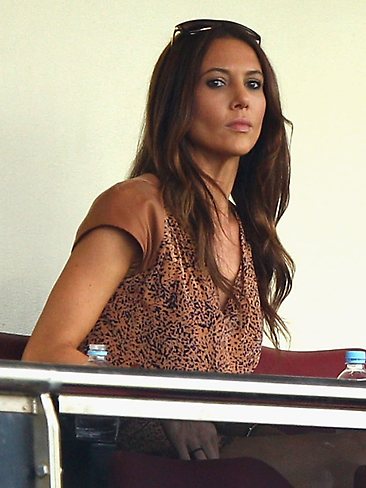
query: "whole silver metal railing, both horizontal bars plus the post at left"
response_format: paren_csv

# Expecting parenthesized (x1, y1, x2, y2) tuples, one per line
(0, 361, 366, 488)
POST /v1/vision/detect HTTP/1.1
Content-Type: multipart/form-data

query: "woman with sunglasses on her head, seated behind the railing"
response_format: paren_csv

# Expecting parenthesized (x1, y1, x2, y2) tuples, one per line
(24, 20, 364, 486)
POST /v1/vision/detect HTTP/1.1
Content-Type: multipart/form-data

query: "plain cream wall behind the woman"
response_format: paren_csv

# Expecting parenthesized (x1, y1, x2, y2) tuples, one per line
(0, 0, 366, 349)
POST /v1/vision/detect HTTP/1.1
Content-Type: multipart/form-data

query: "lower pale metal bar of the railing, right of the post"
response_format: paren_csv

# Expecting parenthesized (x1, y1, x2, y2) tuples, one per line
(59, 395, 366, 429)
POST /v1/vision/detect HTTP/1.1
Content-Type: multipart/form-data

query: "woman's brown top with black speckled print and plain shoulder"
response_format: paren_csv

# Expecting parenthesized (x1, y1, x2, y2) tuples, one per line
(75, 174, 263, 373)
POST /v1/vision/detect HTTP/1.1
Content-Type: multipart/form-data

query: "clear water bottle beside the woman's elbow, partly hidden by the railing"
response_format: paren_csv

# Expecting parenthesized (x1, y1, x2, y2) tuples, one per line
(75, 344, 119, 444)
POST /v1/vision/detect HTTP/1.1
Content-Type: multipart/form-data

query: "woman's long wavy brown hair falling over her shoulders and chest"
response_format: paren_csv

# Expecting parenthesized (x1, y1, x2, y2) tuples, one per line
(130, 24, 294, 347)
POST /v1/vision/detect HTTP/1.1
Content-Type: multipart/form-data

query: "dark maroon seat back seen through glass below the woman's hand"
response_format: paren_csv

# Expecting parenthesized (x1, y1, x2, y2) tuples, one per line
(110, 451, 291, 488)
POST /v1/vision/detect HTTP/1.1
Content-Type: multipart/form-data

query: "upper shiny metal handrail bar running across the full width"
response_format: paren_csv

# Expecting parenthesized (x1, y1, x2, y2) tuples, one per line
(0, 364, 366, 402)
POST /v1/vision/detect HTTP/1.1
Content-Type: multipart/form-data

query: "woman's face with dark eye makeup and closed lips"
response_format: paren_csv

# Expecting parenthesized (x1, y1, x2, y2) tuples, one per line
(188, 38, 266, 169)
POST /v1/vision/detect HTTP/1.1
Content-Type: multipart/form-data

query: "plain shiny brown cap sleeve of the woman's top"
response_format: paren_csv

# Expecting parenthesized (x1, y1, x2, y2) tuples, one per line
(73, 175, 165, 269)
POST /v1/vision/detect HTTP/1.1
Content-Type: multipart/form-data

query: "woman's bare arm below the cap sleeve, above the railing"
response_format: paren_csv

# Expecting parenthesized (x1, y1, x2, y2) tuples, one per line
(23, 227, 141, 364)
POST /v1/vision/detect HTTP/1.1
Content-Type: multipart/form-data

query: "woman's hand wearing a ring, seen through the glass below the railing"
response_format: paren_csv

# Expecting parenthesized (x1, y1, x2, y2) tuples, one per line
(161, 420, 219, 460)
